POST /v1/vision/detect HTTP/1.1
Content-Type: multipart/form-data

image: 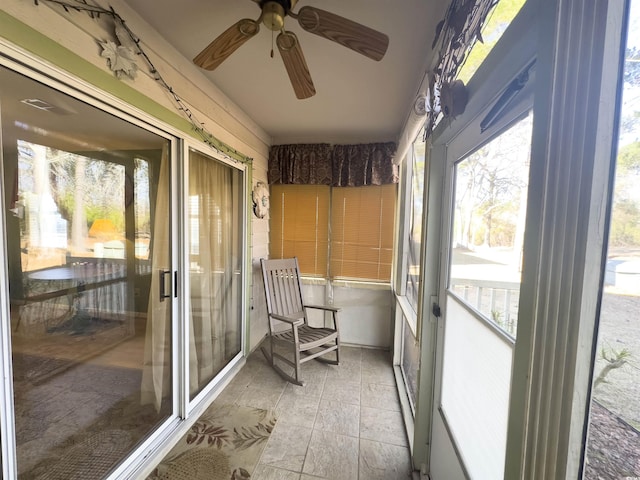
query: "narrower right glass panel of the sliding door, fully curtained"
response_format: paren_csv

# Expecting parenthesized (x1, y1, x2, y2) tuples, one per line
(187, 150, 243, 399)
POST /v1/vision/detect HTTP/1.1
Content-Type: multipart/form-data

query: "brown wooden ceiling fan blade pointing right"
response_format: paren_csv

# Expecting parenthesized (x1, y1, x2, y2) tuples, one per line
(292, 6, 389, 61)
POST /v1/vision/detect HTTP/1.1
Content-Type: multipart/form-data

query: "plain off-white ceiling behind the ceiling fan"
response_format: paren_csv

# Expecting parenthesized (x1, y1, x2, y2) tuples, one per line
(127, 0, 449, 144)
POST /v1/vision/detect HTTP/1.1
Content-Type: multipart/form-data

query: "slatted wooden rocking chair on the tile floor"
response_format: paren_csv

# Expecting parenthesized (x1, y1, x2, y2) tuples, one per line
(260, 257, 340, 385)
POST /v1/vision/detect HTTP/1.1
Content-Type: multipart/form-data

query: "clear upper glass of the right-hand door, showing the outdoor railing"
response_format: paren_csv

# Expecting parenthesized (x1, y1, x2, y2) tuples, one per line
(449, 115, 532, 338)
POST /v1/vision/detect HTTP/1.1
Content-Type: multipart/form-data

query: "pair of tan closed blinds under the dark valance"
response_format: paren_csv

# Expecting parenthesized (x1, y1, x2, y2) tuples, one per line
(270, 185, 396, 282)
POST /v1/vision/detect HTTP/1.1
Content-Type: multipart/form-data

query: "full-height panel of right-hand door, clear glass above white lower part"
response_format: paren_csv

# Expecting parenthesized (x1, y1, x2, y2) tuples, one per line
(441, 111, 532, 479)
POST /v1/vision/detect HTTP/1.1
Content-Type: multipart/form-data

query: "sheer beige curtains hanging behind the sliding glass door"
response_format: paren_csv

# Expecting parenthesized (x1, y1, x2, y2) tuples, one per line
(141, 151, 242, 411)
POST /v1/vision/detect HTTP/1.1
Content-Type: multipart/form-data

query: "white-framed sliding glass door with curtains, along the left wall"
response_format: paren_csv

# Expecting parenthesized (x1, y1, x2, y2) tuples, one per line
(0, 58, 247, 480)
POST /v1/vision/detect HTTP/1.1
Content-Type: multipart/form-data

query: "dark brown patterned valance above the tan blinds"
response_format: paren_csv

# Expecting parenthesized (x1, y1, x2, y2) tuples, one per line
(268, 142, 398, 187)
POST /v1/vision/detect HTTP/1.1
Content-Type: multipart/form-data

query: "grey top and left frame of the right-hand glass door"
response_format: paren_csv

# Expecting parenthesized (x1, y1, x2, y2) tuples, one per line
(423, 3, 537, 480)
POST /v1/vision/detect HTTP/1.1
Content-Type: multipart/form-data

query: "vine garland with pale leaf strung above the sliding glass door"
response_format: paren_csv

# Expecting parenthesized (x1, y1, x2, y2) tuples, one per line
(34, 0, 251, 163)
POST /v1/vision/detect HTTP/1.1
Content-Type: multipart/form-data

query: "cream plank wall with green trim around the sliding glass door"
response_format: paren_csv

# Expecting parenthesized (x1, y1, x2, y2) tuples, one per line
(0, 0, 271, 347)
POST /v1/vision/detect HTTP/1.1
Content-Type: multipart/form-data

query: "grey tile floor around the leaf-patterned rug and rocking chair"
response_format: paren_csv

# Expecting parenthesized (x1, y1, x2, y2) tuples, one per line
(215, 347, 411, 480)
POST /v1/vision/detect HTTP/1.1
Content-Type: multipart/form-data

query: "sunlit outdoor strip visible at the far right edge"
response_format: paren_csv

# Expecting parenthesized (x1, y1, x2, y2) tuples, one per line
(584, 0, 640, 480)
